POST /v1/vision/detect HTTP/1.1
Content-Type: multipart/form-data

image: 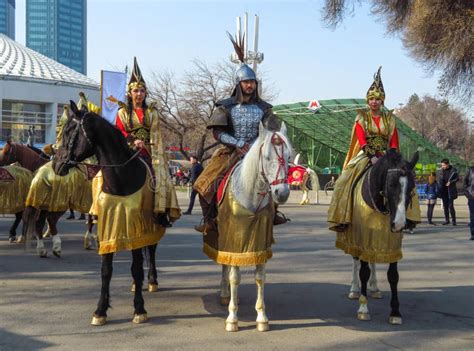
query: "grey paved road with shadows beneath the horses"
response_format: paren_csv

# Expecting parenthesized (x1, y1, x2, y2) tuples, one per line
(0, 193, 474, 350)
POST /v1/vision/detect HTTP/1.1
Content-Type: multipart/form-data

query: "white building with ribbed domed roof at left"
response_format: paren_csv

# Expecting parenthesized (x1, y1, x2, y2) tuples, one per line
(0, 34, 100, 146)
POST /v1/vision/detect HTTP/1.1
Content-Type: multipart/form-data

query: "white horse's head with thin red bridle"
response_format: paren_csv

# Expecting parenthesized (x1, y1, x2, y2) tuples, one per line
(259, 123, 291, 204)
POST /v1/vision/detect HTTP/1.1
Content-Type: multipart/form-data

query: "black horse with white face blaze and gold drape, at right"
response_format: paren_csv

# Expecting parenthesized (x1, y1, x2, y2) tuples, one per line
(336, 150, 418, 324)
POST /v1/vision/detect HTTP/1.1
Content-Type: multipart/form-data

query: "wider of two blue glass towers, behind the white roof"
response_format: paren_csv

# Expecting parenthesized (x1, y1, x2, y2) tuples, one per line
(26, 0, 87, 74)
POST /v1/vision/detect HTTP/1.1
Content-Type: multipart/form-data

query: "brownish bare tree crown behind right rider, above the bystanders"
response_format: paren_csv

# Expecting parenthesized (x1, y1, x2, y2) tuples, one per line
(397, 94, 474, 160)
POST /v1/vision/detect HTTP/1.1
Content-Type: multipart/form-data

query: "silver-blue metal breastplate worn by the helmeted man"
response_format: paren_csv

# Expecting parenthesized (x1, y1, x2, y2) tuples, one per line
(230, 104, 263, 143)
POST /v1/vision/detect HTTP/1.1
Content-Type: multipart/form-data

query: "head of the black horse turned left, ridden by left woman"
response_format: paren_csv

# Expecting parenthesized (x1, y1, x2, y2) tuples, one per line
(53, 101, 94, 176)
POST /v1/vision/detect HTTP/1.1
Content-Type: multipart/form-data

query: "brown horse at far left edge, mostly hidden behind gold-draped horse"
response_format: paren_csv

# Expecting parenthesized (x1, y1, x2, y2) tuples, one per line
(0, 139, 49, 242)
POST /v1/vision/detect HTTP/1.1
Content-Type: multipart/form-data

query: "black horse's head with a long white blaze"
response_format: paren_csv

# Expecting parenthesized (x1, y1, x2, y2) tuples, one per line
(374, 150, 419, 232)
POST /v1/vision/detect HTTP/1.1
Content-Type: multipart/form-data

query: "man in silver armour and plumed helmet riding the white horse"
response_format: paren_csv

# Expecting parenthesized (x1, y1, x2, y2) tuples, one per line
(194, 35, 286, 233)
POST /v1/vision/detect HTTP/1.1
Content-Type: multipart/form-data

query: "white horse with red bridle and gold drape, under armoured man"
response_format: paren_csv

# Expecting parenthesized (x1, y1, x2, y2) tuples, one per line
(204, 124, 291, 331)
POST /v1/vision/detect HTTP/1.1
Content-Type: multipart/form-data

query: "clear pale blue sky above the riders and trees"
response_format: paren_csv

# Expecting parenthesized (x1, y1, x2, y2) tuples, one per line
(16, 0, 438, 108)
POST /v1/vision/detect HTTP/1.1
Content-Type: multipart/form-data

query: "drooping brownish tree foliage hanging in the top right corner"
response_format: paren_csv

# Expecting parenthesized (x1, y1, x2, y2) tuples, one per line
(323, 0, 474, 106)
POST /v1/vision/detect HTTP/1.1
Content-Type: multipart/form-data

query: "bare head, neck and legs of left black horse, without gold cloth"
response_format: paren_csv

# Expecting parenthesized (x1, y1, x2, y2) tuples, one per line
(53, 101, 158, 325)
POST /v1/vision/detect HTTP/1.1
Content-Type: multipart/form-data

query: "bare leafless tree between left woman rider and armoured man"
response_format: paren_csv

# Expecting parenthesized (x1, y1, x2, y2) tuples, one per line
(150, 60, 275, 162)
